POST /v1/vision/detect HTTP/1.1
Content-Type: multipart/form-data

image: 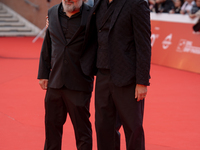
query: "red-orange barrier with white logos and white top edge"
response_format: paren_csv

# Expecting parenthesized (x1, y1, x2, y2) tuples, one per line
(151, 13, 200, 73)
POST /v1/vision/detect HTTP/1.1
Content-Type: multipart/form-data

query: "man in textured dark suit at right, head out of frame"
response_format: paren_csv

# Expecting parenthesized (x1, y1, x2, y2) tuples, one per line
(88, 0, 151, 150)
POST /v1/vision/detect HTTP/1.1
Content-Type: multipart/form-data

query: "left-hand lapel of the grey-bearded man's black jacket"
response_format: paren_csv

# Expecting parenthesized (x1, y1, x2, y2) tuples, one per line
(53, 3, 66, 44)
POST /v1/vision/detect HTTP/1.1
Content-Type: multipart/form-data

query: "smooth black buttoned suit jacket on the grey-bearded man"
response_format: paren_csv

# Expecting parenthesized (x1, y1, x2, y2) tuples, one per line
(38, 4, 95, 91)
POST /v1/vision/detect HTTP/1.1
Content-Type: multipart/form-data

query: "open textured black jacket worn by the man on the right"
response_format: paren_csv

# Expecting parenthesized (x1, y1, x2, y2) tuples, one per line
(86, 0, 151, 86)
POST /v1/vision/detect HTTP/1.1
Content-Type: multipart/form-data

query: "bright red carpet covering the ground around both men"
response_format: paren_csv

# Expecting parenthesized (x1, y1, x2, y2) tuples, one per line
(0, 37, 200, 150)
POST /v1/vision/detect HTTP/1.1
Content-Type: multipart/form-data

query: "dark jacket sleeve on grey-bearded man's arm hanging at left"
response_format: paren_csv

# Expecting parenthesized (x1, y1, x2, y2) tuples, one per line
(37, 28, 51, 79)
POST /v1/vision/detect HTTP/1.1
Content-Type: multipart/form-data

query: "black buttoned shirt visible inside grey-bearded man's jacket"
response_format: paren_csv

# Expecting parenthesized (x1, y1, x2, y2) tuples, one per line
(59, 5, 82, 43)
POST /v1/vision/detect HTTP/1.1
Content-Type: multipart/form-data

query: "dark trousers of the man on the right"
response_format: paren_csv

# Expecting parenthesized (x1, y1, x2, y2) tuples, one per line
(95, 69, 145, 150)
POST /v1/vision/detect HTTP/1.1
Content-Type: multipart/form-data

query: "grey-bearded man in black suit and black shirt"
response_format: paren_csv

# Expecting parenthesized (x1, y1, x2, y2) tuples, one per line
(38, 0, 95, 150)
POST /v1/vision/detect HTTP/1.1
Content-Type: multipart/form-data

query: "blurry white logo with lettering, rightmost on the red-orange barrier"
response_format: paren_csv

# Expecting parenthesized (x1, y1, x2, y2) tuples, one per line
(176, 39, 200, 55)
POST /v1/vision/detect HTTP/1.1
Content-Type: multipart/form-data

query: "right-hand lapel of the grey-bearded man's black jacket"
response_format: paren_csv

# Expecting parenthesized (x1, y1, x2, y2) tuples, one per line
(67, 3, 89, 45)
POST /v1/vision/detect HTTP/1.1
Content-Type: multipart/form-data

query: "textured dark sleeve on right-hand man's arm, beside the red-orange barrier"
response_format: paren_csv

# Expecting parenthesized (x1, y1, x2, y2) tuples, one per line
(132, 0, 151, 85)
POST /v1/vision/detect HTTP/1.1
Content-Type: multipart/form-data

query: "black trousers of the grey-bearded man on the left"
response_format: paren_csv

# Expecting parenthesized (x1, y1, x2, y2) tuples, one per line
(44, 87, 92, 150)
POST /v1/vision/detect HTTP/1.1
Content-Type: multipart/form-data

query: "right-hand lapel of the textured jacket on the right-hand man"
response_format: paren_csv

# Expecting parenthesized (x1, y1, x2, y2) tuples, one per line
(109, 0, 126, 30)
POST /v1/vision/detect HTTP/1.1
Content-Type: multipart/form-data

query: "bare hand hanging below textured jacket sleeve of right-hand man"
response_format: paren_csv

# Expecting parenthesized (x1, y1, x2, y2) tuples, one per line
(135, 84, 147, 101)
